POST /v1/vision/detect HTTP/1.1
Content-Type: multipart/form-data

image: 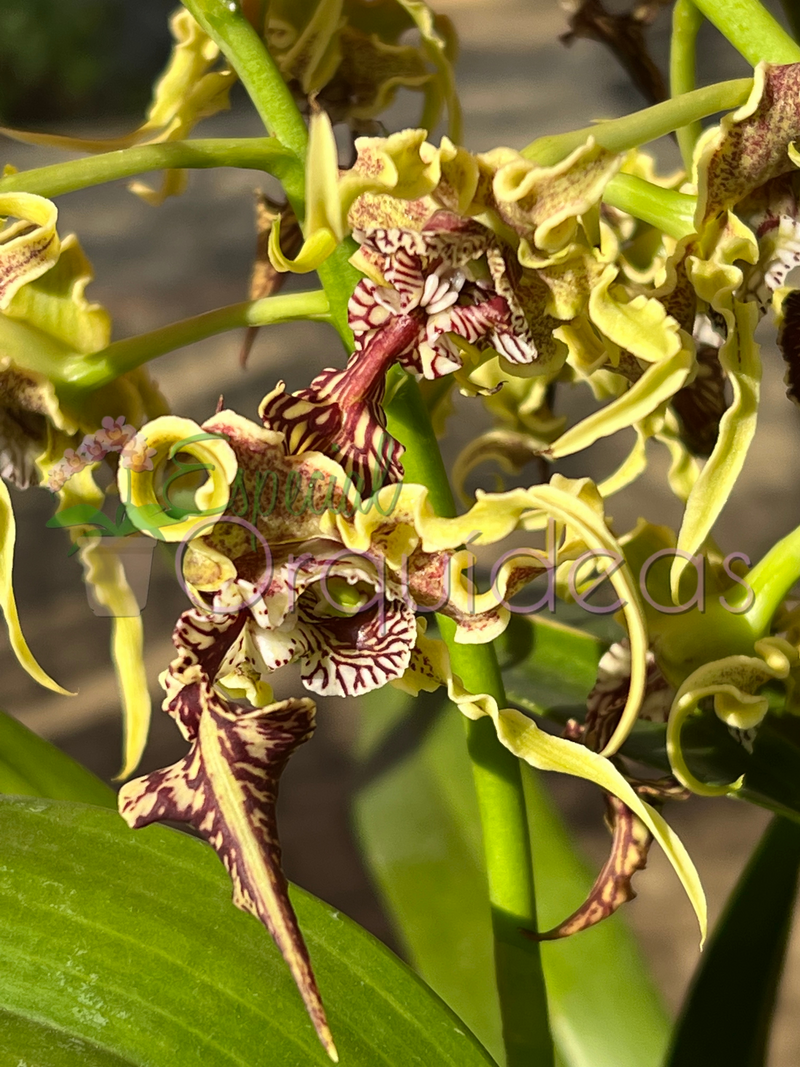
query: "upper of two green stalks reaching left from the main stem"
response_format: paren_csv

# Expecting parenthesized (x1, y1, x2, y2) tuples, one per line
(0, 138, 303, 197)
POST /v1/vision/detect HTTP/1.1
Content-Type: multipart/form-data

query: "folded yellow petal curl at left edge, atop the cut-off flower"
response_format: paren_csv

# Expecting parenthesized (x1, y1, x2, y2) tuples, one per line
(0, 193, 60, 310)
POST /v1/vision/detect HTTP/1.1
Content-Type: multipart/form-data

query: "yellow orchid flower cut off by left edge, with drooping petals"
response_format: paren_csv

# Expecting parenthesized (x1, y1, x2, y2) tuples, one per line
(0, 193, 169, 774)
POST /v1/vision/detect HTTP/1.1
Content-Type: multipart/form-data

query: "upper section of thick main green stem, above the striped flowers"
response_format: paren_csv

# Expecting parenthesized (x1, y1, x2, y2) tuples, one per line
(186, 0, 362, 351)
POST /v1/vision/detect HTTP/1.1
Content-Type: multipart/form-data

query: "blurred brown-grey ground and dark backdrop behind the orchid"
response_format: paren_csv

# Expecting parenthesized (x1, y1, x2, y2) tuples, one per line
(0, 0, 800, 1067)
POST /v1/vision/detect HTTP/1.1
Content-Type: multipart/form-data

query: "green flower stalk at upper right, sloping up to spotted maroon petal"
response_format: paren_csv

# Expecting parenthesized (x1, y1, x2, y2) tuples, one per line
(522, 78, 753, 166)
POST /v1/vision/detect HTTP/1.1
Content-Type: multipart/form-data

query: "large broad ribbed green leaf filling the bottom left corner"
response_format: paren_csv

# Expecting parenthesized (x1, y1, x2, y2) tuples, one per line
(0, 798, 499, 1067)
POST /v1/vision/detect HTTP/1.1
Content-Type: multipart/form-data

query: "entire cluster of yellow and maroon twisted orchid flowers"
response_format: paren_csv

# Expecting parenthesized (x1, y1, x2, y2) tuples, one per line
(0, 0, 800, 1058)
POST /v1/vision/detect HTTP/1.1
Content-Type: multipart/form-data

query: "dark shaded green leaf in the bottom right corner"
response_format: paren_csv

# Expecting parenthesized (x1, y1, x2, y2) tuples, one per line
(667, 818, 800, 1067)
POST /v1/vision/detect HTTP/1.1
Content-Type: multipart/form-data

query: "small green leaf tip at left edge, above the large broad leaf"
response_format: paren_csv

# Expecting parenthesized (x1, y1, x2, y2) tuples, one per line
(0, 712, 116, 809)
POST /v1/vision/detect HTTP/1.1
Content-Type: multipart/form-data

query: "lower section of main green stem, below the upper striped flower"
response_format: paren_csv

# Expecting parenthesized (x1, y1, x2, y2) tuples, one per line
(386, 372, 554, 1067)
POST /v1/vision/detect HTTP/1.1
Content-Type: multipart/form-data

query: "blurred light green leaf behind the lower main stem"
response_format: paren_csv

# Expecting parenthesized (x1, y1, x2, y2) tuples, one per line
(355, 674, 669, 1067)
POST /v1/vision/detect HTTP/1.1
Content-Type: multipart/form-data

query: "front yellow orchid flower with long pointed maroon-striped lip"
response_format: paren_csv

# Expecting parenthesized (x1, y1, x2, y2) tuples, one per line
(111, 396, 705, 1037)
